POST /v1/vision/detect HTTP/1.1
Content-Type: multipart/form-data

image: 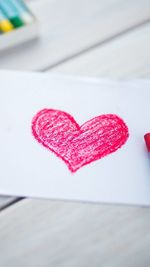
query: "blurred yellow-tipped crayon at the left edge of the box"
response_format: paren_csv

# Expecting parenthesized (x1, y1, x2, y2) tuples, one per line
(0, 9, 14, 33)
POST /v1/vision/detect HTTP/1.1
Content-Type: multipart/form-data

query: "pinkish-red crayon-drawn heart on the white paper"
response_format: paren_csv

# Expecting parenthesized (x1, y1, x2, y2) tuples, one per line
(32, 109, 129, 172)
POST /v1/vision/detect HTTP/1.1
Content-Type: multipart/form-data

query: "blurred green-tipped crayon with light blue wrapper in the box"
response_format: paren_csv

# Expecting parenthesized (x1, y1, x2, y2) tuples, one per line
(0, 0, 24, 28)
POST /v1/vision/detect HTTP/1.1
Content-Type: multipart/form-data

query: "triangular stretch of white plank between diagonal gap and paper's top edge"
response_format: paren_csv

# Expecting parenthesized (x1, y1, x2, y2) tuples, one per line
(51, 23, 150, 79)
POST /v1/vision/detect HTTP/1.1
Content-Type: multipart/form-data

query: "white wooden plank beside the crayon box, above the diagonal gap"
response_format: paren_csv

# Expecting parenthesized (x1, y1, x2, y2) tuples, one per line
(0, 0, 150, 70)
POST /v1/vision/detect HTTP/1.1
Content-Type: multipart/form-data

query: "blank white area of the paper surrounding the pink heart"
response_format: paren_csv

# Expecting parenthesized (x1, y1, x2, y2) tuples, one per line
(0, 71, 150, 205)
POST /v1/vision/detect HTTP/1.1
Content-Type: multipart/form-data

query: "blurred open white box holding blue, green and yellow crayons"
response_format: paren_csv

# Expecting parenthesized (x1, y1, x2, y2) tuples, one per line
(0, 0, 38, 51)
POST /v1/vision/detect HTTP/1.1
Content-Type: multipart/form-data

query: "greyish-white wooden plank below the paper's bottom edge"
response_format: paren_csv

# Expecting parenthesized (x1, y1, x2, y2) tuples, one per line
(0, 200, 150, 267)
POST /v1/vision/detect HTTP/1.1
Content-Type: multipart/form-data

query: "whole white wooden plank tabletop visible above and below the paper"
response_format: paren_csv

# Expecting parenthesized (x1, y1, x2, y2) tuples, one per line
(0, 0, 150, 267)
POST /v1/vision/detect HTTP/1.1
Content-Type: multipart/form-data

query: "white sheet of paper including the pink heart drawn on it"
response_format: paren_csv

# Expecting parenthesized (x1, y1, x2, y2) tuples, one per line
(0, 71, 150, 205)
